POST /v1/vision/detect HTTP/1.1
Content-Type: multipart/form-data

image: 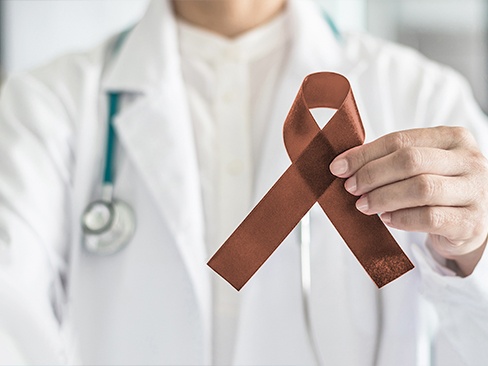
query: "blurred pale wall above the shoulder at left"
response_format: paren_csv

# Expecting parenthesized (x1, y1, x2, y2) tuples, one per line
(1, 0, 147, 73)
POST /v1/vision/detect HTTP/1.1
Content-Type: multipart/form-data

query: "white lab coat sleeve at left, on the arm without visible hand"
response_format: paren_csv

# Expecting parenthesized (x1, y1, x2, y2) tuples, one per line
(0, 74, 73, 364)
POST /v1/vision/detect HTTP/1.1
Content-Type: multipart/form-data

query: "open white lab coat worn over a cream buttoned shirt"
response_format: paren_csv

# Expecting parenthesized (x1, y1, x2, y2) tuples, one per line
(0, 0, 488, 366)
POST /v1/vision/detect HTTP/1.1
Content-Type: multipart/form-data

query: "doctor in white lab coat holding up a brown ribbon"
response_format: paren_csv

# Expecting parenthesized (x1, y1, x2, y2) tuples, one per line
(0, 0, 488, 366)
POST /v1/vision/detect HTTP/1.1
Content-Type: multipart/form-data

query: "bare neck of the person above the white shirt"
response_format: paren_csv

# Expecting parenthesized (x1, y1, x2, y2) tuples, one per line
(172, 0, 286, 38)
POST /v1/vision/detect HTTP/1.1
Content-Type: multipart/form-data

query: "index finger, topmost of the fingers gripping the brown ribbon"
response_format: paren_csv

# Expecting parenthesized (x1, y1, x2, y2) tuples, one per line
(330, 126, 473, 178)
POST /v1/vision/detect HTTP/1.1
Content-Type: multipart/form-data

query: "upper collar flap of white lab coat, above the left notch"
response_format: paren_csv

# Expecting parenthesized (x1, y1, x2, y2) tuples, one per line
(102, 0, 180, 94)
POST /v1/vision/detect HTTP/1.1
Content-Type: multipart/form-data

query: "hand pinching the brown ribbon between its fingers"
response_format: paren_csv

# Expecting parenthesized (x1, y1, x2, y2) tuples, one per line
(330, 127, 488, 275)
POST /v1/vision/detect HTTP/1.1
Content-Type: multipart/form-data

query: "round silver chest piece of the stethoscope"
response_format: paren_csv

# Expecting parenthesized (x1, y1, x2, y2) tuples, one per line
(82, 200, 136, 255)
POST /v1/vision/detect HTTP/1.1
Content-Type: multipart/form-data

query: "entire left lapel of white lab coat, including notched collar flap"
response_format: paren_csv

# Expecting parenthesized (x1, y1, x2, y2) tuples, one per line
(102, 1, 211, 354)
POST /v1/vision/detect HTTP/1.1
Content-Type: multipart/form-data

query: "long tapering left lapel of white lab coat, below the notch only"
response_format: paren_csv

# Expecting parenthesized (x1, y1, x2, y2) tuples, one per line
(114, 91, 211, 339)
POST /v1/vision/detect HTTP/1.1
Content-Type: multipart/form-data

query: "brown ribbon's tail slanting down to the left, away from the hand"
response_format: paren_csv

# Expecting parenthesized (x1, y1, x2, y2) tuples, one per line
(207, 165, 317, 291)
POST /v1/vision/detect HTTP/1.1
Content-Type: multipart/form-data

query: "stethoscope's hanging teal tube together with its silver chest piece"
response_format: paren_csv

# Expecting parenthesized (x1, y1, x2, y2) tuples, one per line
(81, 93, 136, 255)
